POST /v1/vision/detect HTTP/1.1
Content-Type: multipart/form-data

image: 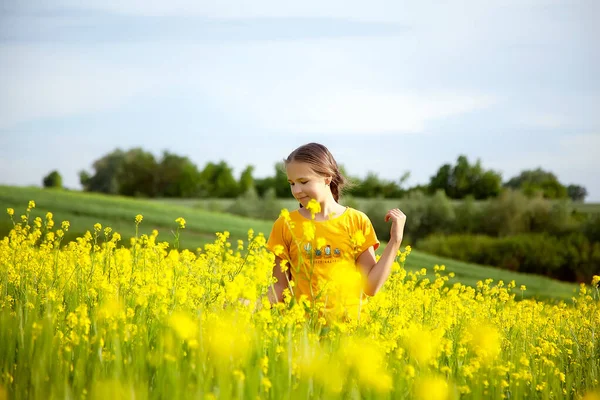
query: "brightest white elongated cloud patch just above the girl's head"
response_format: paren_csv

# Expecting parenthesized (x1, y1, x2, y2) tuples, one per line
(232, 87, 493, 134)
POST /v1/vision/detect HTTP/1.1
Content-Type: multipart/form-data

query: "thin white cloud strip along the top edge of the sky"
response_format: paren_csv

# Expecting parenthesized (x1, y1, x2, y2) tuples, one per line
(21, 0, 564, 22)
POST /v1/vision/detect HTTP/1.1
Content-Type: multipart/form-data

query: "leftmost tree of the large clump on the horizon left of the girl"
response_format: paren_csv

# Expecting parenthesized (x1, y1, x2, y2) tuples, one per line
(79, 149, 125, 194)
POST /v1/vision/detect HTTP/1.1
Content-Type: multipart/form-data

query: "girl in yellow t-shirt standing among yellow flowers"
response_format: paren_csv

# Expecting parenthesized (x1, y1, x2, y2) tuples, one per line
(267, 143, 406, 314)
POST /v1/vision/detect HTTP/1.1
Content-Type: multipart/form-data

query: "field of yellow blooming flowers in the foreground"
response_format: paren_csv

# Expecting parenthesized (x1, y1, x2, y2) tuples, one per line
(0, 202, 600, 399)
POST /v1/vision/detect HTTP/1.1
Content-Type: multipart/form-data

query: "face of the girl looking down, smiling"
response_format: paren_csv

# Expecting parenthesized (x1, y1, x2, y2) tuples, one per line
(286, 161, 331, 207)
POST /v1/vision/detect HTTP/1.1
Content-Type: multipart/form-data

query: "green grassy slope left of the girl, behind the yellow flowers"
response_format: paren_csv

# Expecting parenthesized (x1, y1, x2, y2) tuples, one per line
(0, 186, 271, 249)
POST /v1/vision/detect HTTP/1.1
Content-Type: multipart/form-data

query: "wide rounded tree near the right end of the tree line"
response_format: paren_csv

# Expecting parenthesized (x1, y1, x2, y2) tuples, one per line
(504, 168, 567, 199)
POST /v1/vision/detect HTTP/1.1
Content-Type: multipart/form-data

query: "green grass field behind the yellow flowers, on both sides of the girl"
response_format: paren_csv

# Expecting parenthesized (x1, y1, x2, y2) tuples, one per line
(0, 186, 577, 300)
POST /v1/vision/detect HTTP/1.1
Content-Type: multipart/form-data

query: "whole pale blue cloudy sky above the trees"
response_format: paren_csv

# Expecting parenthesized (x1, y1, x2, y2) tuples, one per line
(0, 0, 600, 201)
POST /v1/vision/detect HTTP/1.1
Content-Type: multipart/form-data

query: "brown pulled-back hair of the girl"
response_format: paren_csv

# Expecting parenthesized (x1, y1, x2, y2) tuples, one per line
(284, 143, 348, 201)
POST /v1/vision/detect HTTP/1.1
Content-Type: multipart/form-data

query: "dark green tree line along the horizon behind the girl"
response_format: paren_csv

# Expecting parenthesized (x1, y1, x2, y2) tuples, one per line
(43, 148, 587, 201)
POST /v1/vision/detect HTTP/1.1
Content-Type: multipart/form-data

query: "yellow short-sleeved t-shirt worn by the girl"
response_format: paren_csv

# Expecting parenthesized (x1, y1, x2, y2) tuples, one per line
(267, 207, 379, 310)
